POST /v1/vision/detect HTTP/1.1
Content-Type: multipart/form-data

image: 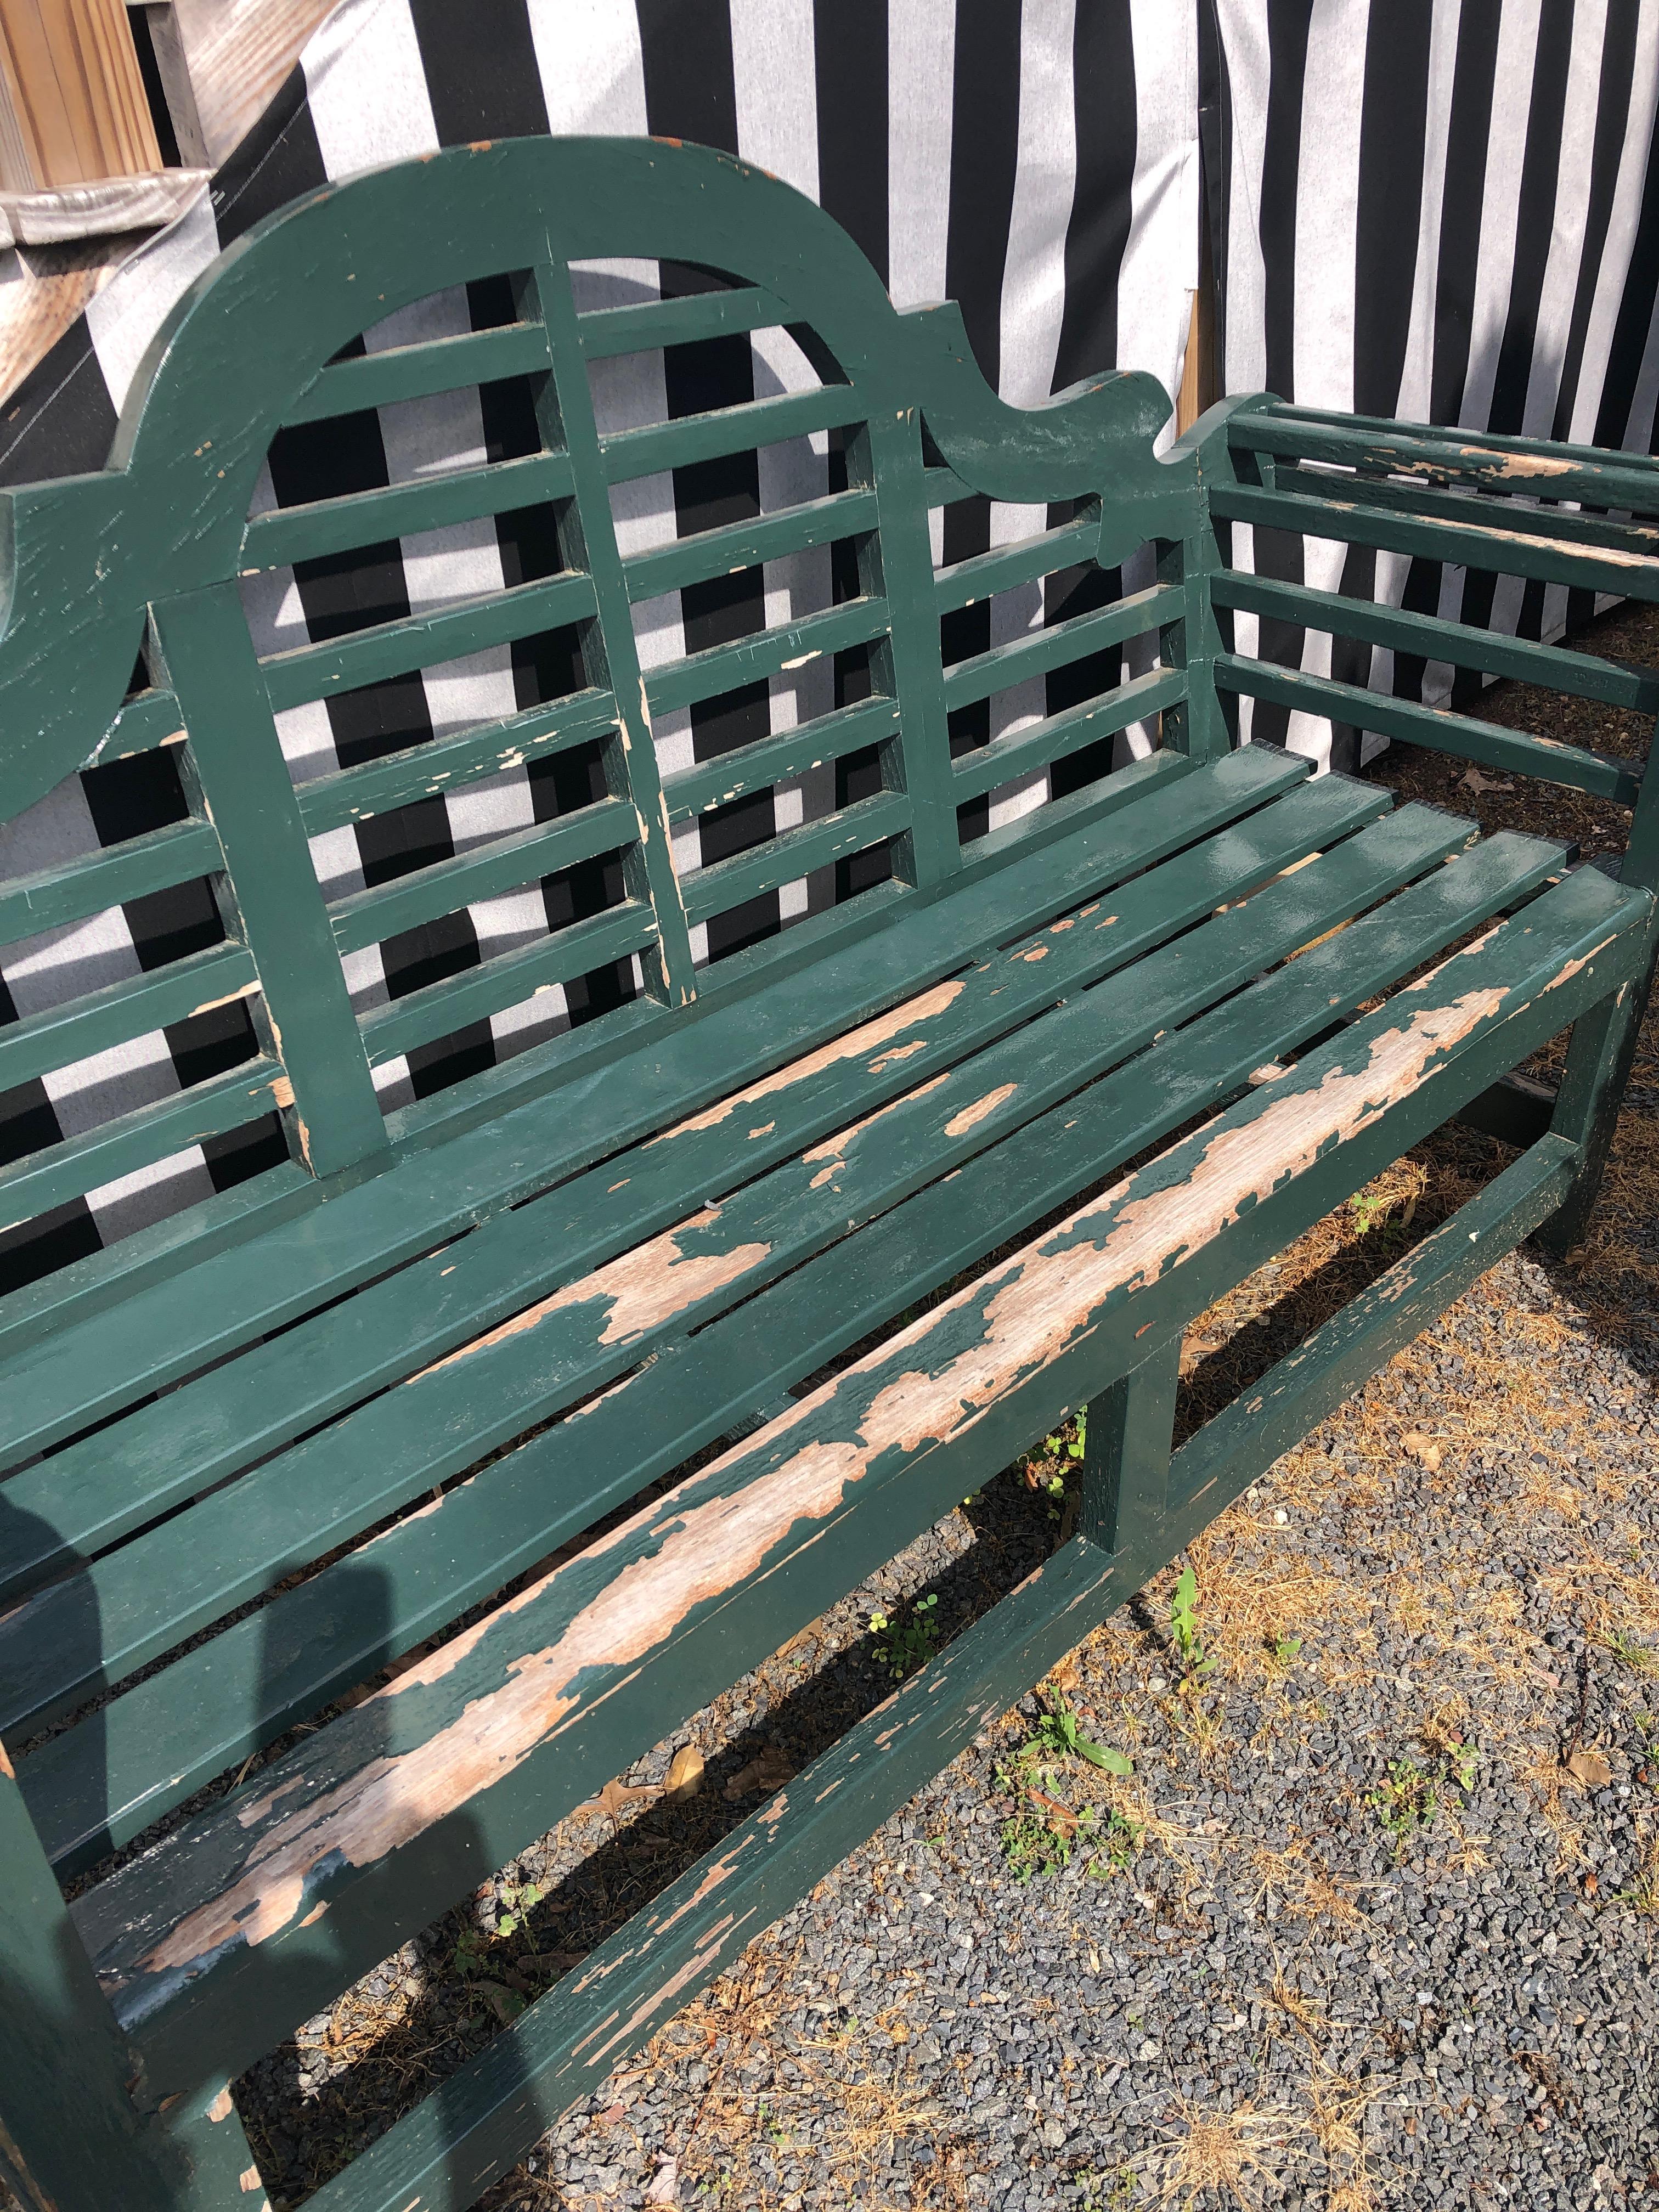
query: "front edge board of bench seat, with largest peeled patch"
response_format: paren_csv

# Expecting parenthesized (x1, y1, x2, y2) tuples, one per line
(75, 870, 1652, 2092)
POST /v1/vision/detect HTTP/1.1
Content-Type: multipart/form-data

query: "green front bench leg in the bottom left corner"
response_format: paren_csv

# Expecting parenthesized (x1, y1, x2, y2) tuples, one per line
(0, 1750, 266, 2212)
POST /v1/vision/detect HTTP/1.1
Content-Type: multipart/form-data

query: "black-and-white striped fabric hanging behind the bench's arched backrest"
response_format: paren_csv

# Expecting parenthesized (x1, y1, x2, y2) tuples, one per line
(0, 0, 1199, 1288)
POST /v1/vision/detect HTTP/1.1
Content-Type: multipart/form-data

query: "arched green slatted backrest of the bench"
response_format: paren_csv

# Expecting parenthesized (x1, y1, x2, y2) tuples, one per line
(0, 142, 1194, 1327)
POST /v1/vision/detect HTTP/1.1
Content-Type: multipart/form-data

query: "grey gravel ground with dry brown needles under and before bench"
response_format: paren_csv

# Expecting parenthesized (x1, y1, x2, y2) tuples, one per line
(13, 617, 1659, 2212)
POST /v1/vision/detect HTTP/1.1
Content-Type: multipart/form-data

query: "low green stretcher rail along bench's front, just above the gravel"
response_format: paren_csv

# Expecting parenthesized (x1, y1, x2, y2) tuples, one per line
(309, 1137, 1601, 2212)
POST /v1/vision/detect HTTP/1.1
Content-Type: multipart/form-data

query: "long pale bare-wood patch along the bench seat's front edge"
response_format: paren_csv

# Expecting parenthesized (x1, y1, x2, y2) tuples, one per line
(142, 940, 1557, 1973)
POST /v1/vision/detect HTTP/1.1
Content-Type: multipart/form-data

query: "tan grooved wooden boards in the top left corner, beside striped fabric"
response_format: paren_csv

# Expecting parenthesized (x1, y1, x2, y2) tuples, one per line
(0, 0, 161, 193)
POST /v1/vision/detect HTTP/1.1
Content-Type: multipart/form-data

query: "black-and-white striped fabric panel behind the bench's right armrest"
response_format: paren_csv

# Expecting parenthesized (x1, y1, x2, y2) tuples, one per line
(1205, 0, 1659, 768)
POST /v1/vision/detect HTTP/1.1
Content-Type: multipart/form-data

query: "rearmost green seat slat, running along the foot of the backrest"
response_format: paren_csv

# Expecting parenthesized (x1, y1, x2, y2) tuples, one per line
(0, 746, 1256, 1469)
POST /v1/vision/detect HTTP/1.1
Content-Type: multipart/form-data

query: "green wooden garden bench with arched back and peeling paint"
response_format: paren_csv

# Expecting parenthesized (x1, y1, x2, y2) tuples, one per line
(0, 142, 1659, 2212)
